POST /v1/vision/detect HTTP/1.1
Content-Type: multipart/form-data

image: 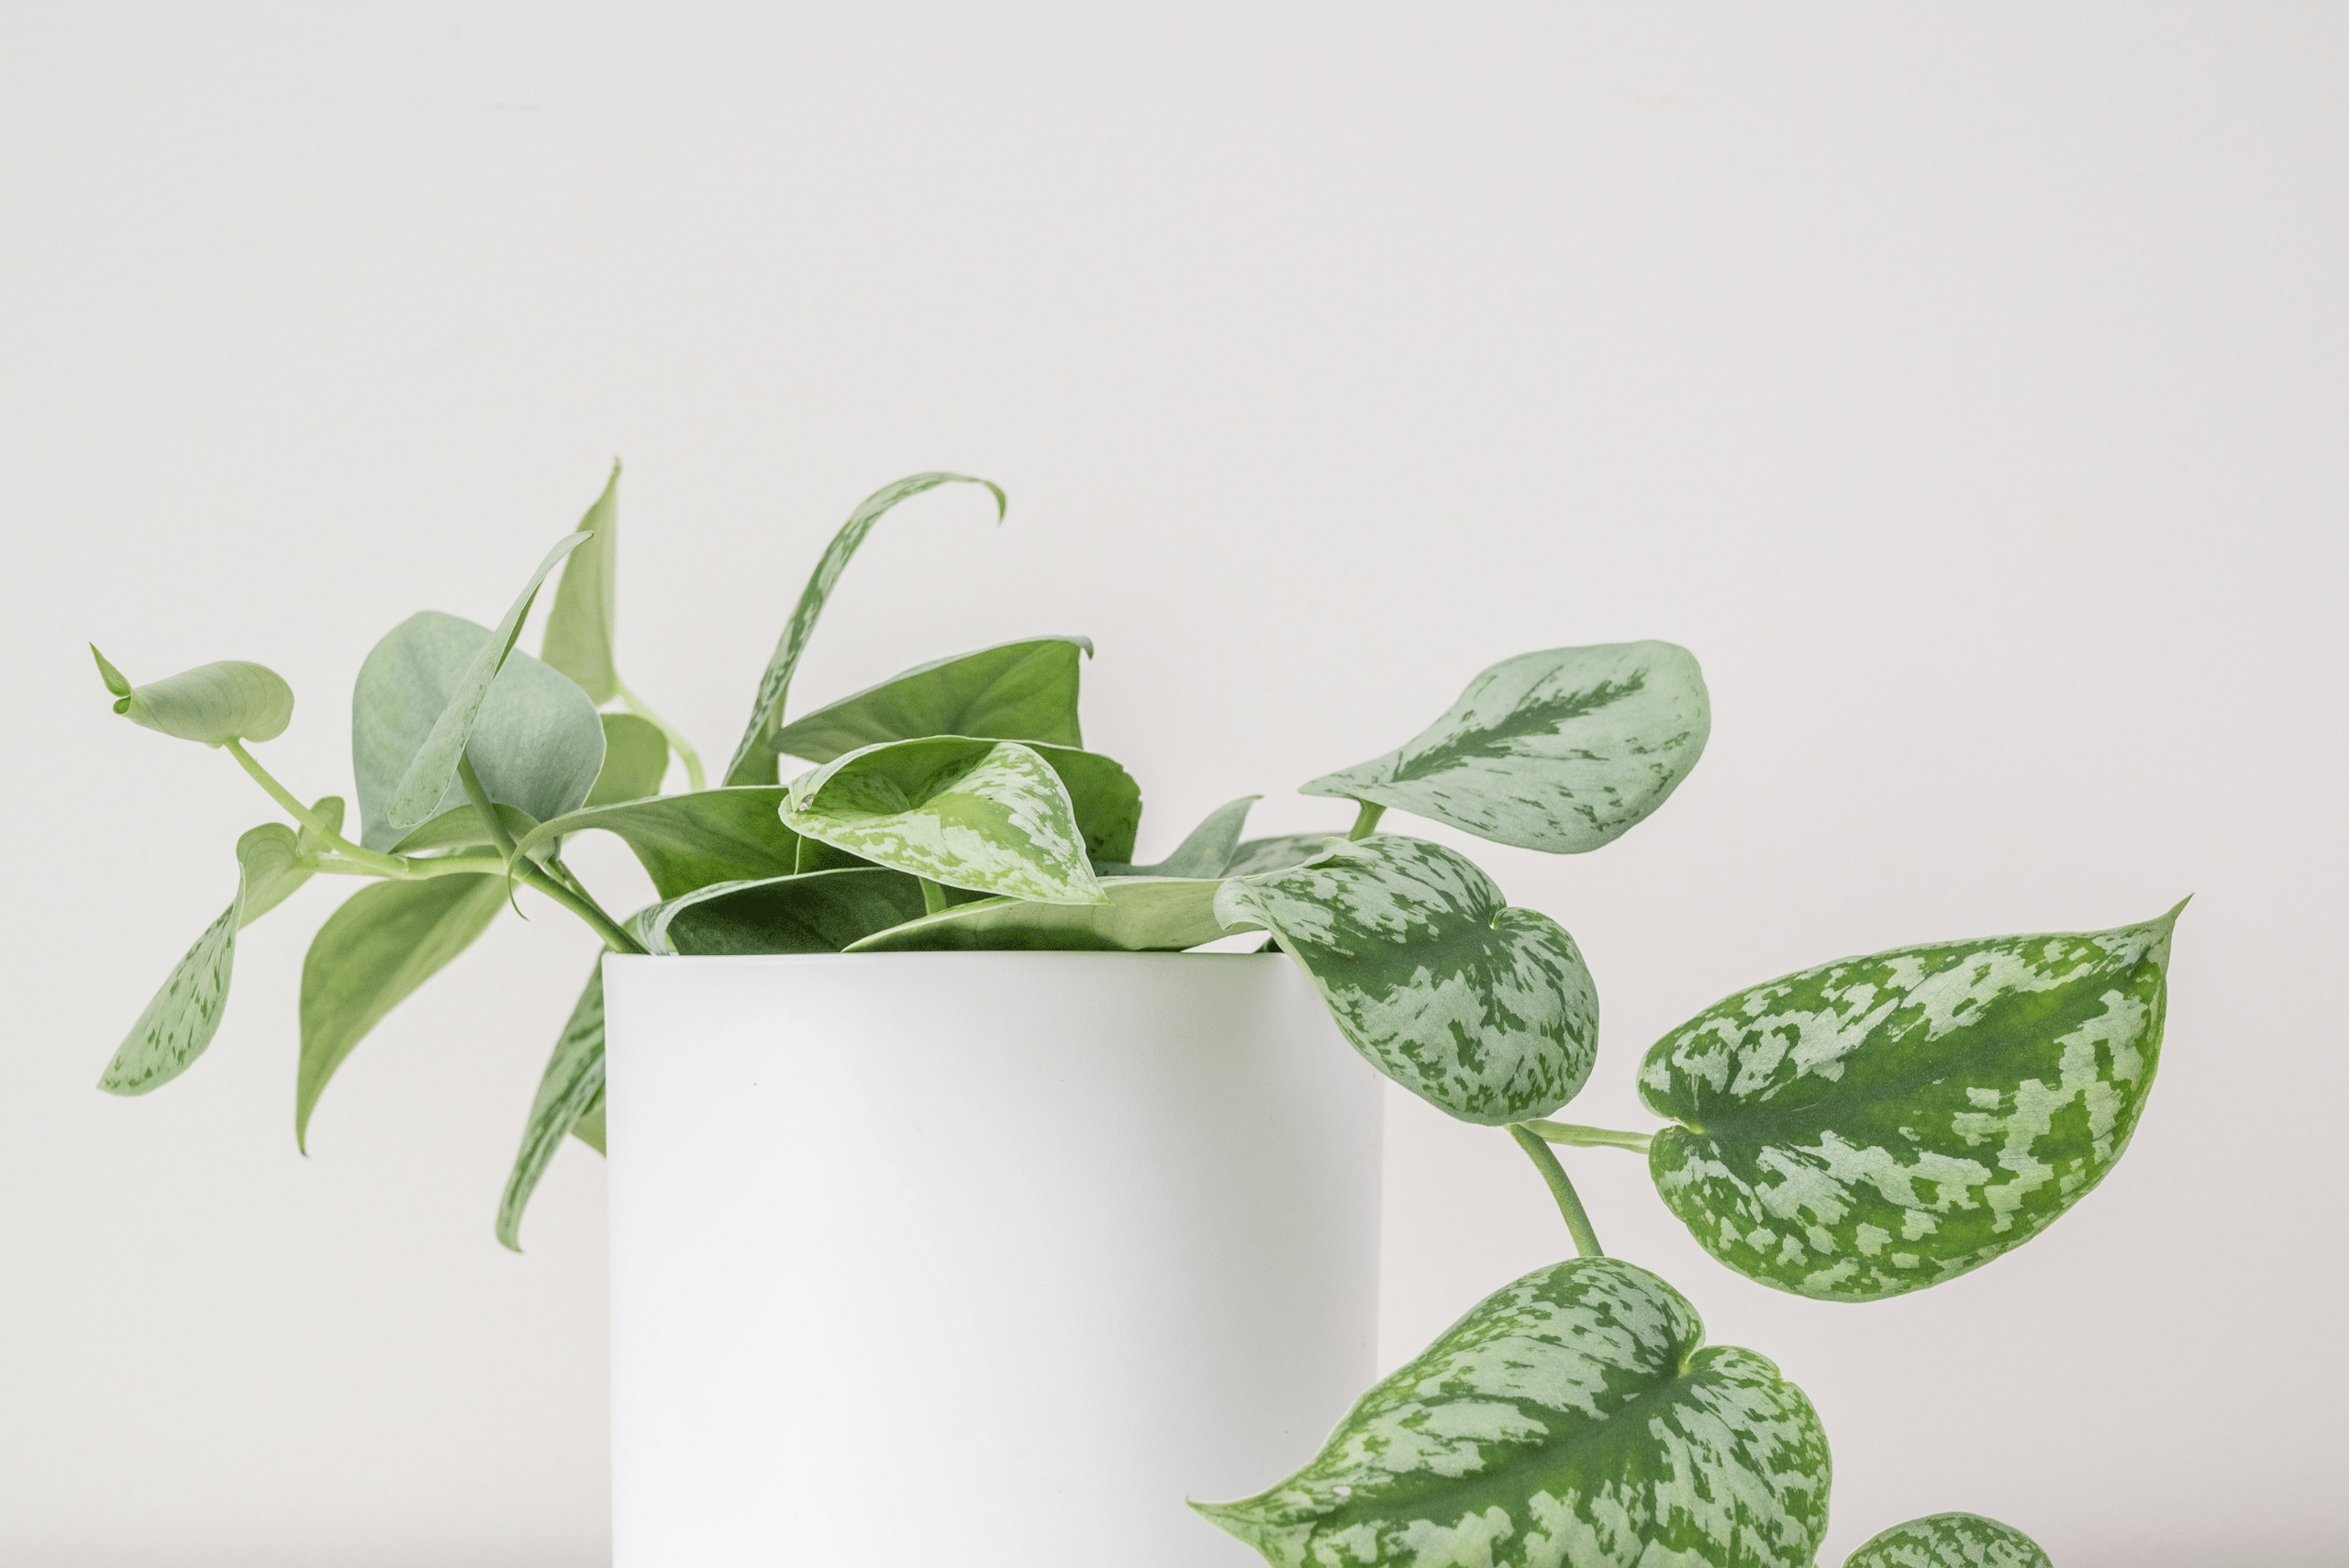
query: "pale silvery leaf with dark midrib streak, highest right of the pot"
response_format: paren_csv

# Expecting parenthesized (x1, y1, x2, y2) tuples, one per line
(1304, 643, 1712, 854)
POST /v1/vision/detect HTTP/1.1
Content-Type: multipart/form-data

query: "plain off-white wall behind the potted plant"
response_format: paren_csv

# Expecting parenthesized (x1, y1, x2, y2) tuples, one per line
(0, 5, 2349, 1568)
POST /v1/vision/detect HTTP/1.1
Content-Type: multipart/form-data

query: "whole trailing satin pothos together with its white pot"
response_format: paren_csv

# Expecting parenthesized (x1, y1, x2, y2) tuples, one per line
(92, 467, 2177, 1568)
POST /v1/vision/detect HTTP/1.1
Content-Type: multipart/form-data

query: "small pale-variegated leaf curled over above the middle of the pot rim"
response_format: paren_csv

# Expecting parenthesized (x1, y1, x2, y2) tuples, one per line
(782, 735, 1123, 904)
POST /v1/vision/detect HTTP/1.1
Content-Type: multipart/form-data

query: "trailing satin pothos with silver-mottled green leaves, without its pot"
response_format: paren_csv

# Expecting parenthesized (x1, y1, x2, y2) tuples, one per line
(92, 467, 2177, 1568)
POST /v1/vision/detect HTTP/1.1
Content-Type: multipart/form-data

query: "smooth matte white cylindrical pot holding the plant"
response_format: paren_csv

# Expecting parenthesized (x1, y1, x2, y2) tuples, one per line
(604, 953, 1379, 1568)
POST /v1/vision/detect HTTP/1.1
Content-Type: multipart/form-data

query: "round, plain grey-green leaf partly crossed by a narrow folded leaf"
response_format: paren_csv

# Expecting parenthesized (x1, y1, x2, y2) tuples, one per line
(350, 610, 604, 850)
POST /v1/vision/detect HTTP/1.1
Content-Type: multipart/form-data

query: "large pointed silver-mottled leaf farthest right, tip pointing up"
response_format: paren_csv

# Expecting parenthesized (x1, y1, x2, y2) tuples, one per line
(1640, 904, 2185, 1300)
